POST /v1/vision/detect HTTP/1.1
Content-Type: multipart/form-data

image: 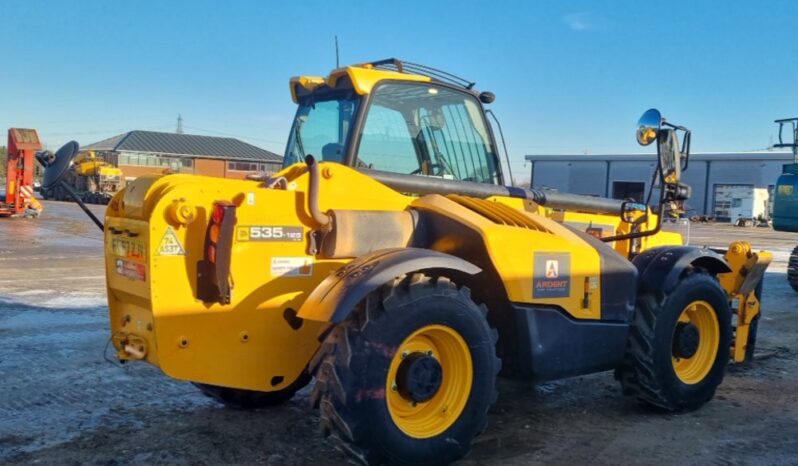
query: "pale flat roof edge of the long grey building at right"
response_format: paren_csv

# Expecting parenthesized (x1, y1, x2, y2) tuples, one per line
(525, 150, 793, 162)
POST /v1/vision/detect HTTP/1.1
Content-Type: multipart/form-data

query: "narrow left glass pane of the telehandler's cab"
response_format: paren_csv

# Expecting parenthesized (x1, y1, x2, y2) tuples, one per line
(283, 97, 357, 167)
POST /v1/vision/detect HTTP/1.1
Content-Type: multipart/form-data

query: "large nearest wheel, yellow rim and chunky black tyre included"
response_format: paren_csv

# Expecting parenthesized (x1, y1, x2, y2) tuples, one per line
(311, 274, 501, 464)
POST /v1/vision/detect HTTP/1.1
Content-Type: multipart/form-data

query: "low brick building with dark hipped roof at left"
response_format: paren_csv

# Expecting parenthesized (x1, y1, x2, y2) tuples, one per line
(81, 131, 283, 181)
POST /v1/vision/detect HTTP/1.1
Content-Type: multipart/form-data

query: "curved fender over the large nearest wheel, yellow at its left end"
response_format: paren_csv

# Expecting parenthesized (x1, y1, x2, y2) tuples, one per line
(297, 248, 482, 323)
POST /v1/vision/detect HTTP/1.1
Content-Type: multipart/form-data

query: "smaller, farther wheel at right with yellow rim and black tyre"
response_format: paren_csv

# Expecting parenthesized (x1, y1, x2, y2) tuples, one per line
(616, 271, 731, 411)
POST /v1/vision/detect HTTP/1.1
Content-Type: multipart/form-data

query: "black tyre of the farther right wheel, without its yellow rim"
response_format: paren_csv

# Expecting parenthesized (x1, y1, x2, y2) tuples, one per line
(615, 271, 732, 412)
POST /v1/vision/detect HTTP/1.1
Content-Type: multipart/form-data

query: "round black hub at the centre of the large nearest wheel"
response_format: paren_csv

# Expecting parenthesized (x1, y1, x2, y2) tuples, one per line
(396, 351, 443, 403)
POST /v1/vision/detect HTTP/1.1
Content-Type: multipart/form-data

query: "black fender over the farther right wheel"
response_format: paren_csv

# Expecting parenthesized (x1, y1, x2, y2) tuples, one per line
(632, 246, 732, 293)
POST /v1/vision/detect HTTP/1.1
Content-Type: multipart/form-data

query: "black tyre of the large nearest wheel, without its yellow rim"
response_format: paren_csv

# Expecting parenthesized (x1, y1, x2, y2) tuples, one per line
(311, 274, 501, 465)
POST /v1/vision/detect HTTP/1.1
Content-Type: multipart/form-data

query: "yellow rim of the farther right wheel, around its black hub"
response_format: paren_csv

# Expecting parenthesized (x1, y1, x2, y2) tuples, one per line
(671, 301, 720, 385)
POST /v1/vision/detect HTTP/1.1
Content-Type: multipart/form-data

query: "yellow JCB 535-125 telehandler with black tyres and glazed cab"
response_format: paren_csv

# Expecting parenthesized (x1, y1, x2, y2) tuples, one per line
(40, 59, 770, 464)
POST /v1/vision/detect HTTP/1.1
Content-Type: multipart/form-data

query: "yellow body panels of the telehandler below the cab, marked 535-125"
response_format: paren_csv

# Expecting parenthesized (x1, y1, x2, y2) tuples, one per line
(105, 163, 692, 391)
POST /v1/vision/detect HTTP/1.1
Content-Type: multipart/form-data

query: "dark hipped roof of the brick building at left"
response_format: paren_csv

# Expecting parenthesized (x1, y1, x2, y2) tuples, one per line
(82, 130, 283, 162)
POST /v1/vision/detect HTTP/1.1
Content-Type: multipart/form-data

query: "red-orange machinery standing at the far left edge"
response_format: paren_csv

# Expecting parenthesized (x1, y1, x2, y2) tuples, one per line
(0, 128, 42, 216)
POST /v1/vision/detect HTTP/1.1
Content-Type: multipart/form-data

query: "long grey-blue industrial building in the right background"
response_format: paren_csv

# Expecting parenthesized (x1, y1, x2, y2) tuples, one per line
(526, 150, 793, 221)
